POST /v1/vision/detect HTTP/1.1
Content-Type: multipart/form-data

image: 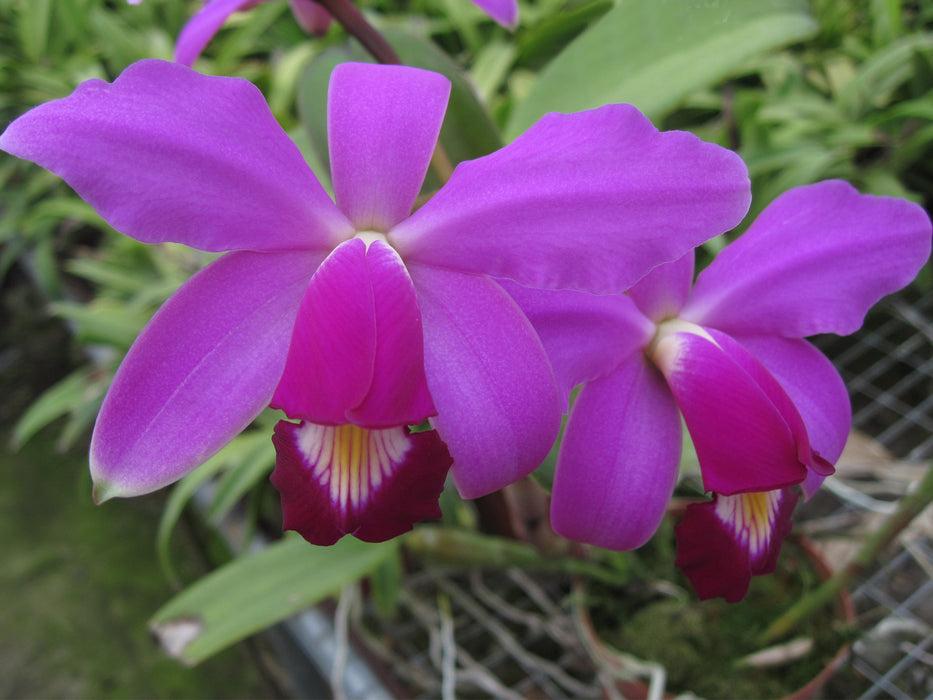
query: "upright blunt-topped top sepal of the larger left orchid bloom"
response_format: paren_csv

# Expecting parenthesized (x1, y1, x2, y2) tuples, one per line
(327, 63, 450, 233)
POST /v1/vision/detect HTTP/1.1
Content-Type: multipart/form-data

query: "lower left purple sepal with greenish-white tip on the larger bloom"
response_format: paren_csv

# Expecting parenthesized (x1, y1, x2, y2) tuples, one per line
(90, 252, 320, 502)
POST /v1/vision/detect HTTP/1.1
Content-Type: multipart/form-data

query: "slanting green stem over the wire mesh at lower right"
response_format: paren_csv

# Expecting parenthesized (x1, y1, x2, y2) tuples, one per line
(761, 463, 933, 644)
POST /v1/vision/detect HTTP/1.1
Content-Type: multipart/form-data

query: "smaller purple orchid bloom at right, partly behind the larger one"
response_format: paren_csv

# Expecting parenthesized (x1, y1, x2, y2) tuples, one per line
(504, 181, 931, 601)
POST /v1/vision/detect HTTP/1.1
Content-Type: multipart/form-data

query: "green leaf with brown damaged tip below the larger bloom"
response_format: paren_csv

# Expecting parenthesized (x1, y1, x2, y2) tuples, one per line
(149, 536, 397, 664)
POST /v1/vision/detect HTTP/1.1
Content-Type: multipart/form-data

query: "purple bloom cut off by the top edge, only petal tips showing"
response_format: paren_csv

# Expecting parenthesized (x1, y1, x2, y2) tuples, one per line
(127, 0, 518, 66)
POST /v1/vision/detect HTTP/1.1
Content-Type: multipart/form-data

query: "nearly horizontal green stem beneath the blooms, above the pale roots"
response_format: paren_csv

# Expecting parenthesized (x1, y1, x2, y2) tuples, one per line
(404, 525, 620, 585)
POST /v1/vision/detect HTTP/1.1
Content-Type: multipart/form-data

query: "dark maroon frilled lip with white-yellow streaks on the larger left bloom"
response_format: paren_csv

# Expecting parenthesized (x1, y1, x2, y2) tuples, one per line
(272, 421, 452, 546)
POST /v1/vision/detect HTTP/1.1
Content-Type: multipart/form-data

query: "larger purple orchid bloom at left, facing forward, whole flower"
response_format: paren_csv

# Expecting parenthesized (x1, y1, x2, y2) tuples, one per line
(0, 60, 750, 543)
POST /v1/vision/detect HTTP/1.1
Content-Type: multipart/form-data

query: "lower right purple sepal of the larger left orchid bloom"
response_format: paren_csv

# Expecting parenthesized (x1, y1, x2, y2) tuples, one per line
(408, 265, 561, 498)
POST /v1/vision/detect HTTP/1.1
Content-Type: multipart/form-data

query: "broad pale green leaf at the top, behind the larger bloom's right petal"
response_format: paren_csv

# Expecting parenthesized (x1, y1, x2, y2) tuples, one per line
(506, 0, 817, 140)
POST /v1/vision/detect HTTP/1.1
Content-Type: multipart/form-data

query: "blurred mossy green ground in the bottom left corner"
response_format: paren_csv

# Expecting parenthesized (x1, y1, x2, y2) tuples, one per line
(0, 434, 269, 698)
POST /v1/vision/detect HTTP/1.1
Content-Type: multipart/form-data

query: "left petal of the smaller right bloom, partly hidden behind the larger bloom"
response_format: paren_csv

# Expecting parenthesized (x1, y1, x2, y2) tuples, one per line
(499, 280, 655, 412)
